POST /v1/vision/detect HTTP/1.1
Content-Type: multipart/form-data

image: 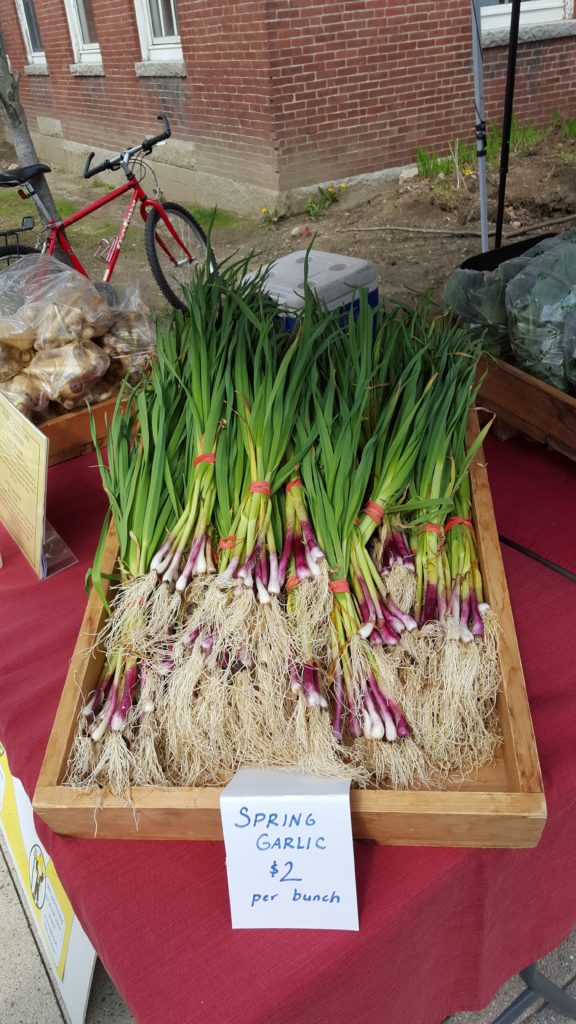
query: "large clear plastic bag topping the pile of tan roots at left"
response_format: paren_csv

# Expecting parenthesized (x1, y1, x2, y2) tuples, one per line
(0, 254, 114, 350)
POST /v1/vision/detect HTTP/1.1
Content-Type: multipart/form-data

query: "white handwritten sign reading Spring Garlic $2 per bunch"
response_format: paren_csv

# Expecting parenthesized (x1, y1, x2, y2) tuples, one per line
(220, 768, 358, 931)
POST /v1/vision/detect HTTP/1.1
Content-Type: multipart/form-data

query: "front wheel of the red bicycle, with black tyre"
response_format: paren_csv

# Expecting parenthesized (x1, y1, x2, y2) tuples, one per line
(145, 203, 216, 309)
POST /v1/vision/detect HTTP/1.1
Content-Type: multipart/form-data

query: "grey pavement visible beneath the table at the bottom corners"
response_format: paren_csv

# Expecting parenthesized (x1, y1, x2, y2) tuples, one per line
(0, 837, 576, 1024)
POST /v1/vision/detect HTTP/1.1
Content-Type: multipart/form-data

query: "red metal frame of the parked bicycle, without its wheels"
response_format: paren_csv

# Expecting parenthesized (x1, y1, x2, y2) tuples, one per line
(39, 177, 194, 282)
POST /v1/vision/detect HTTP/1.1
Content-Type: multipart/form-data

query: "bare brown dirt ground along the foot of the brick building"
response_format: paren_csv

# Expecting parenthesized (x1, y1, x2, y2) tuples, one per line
(0, 128, 576, 301)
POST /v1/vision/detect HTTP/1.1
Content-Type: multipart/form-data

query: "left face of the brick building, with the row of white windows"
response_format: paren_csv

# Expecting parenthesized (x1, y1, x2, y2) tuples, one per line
(0, 0, 278, 199)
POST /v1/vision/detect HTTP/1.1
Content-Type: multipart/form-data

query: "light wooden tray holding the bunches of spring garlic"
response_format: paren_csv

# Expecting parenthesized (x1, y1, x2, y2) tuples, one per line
(34, 417, 546, 847)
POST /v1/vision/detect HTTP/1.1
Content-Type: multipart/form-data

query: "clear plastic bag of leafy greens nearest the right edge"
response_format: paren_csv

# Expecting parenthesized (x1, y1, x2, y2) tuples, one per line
(506, 241, 576, 391)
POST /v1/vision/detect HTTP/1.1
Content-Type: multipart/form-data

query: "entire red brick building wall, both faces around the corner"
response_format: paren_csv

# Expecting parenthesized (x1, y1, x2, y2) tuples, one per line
(0, 0, 576, 207)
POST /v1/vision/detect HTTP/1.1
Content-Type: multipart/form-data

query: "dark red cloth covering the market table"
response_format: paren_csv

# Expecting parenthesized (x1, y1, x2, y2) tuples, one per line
(0, 440, 576, 1024)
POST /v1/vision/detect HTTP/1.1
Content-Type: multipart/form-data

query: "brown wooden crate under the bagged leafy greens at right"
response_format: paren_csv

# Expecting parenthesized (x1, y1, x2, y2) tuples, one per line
(479, 355, 576, 460)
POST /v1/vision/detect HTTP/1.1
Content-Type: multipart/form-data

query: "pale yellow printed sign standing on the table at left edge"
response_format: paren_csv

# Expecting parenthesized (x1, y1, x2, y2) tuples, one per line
(0, 394, 48, 579)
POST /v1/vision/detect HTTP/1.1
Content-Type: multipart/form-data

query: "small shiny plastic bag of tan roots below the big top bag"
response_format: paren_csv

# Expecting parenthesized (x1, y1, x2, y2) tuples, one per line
(27, 341, 110, 411)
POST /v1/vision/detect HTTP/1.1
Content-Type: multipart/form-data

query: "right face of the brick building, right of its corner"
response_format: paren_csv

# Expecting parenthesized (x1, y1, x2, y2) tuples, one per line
(270, 0, 576, 188)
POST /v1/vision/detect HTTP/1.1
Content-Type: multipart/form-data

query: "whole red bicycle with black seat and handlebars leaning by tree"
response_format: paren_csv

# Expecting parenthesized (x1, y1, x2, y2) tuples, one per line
(0, 114, 215, 309)
